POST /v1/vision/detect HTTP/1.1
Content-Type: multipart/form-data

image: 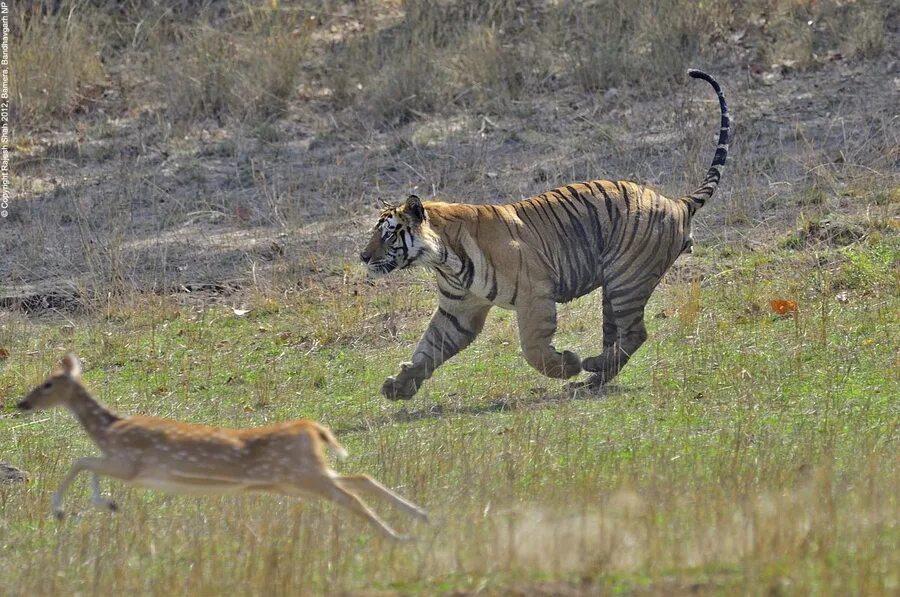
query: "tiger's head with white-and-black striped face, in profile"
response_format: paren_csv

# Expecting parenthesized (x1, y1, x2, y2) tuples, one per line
(359, 195, 437, 275)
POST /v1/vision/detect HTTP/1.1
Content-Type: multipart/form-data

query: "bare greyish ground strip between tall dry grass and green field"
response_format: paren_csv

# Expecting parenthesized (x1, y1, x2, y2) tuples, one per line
(0, 4, 900, 311)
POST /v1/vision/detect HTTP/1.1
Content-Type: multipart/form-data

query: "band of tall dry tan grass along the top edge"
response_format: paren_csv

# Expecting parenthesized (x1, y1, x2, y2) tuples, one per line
(13, 0, 897, 127)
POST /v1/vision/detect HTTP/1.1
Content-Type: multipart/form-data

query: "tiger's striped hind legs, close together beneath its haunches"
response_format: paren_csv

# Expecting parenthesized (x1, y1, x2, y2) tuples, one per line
(581, 283, 656, 387)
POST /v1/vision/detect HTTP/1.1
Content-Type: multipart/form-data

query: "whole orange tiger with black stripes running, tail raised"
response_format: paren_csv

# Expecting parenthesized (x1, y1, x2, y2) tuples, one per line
(359, 69, 731, 400)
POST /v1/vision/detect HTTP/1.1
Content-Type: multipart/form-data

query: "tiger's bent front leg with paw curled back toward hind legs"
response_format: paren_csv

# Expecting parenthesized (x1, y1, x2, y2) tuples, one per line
(516, 298, 581, 379)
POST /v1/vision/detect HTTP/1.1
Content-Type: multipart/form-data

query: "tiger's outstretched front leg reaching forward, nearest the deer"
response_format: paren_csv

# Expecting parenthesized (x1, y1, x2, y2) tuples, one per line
(381, 295, 491, 400)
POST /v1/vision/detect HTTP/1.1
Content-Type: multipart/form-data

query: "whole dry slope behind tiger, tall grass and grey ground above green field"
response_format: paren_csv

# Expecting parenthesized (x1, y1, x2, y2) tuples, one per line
(0, 0, 898, 308)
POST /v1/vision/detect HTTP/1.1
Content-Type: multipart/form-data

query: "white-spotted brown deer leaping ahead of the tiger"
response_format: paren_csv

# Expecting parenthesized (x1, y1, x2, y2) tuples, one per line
(18, 353, 428, 540)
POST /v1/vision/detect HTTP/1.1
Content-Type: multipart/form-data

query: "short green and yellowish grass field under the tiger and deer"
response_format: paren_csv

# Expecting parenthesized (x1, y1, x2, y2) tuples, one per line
(0, 236, 900, 595)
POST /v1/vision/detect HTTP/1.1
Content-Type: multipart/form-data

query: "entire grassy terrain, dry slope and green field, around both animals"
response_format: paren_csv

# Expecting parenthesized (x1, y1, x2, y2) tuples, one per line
(0, 0, 900, 594)
